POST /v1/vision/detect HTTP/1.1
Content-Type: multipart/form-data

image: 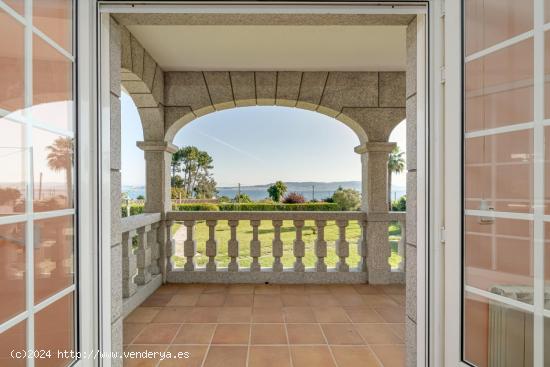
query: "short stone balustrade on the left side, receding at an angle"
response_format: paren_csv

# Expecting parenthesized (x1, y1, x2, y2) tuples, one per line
(121, 213, 162, 315)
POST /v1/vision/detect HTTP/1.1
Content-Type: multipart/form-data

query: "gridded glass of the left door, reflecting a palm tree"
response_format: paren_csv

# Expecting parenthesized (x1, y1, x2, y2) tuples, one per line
(0, 0, 78, 367)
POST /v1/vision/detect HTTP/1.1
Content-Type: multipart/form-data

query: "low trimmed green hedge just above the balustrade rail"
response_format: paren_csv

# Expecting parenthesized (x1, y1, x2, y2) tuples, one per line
(121, 202, 340, 217)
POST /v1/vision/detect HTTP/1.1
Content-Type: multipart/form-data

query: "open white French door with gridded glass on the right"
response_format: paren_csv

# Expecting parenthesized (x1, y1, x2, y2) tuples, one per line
(445, 0, 550, 367)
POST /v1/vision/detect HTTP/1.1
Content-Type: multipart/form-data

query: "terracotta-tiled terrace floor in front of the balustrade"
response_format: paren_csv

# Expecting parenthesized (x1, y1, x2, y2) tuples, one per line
(124, 284, 405, 367)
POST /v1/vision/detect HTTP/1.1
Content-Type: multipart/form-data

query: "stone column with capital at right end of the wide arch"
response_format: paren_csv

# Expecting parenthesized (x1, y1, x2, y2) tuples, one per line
(355, 142, 396, 284)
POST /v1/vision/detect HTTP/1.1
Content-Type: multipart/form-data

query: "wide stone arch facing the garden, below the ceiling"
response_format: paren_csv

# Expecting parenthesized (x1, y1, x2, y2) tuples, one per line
(164, 71, 405, 144)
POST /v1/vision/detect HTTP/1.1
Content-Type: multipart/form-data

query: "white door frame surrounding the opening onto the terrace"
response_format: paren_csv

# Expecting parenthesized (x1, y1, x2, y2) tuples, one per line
(93, 0, 438, 366)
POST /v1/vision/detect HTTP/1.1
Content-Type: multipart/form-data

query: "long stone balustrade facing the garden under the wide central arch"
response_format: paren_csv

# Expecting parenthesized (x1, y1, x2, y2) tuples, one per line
(164, 211, 406, 283)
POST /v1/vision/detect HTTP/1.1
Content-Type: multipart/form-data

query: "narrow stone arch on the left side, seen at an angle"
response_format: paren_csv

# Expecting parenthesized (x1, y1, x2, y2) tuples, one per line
(119, 26, 164, 141)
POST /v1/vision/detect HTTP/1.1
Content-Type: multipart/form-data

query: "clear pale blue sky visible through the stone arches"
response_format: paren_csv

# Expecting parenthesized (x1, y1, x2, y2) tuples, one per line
(122, 93, 406, 187)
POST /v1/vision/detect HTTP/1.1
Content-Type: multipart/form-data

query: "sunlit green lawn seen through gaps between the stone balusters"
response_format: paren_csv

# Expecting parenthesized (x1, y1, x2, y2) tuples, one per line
(172, 221, 401, 268)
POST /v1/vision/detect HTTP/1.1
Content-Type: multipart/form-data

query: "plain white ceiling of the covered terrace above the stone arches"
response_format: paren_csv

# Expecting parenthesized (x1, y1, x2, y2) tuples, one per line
(128, 25, 406, 71)
